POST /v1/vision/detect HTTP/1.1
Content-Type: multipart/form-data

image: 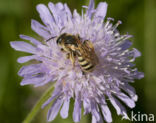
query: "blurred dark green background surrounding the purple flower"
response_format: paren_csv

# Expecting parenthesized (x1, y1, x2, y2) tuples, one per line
(0, 0, 156, 123)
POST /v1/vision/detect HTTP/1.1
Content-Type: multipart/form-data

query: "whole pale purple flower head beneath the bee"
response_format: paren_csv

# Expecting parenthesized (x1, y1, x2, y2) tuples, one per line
(11, 0, 144, 123)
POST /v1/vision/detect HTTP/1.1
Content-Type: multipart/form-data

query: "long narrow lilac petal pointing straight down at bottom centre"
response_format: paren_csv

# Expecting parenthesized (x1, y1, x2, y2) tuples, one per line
(73, 93, 81, 122)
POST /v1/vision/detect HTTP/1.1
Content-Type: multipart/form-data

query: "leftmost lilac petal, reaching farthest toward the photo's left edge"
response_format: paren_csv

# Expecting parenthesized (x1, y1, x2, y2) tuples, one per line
(10, 41, 37, 54)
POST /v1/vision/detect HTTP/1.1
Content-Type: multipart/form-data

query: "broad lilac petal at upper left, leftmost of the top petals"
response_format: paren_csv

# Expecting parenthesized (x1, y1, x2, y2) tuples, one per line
(36, 4, 54, 29)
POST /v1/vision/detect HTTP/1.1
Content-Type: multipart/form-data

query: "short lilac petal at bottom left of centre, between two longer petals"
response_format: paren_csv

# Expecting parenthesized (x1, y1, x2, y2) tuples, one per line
(60, 99, 70, 119)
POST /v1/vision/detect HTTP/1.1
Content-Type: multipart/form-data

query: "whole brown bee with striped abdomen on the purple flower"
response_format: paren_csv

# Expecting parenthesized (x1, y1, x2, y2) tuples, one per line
(47, 33, 98, 73)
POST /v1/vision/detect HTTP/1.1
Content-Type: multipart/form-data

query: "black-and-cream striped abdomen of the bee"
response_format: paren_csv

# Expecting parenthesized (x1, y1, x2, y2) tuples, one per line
(78, 56, 95, 72)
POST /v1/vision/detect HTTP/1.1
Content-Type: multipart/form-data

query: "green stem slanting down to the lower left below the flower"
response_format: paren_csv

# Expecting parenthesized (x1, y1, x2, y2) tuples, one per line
(23, 85, 54, 123)
